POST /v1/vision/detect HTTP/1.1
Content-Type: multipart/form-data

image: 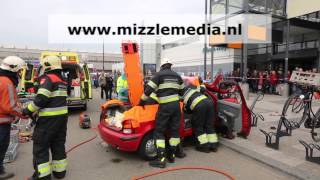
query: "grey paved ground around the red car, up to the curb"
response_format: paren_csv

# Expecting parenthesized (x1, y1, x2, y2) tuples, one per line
(8, 89, 303, 180)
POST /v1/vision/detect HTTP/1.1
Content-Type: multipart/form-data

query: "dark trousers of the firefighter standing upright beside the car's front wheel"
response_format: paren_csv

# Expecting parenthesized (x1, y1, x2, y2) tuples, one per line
(154, 101, 181, 150)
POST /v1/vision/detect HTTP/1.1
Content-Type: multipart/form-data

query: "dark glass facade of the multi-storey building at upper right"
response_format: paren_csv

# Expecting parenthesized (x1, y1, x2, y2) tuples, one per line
(211, 0, 320, 73)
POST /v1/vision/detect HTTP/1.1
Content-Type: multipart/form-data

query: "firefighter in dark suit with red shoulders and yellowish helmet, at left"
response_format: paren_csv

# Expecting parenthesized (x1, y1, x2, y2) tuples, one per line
(23, 56, 68, 180)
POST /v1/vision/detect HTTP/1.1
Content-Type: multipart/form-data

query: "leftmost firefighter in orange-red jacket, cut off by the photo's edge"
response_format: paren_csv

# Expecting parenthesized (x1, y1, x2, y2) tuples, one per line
(0, 56, 25, 179)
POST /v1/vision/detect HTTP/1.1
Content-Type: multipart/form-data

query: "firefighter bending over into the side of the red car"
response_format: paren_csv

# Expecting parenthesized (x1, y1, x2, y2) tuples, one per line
(182, 80, 218, 153)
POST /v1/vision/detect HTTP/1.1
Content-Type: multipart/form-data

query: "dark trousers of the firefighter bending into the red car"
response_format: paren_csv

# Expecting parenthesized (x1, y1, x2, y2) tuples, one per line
(191, 99, 217, 144)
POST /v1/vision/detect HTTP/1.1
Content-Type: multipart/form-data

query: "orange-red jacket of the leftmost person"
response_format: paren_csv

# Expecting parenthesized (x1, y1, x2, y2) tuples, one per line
(0, 76, 23, 124)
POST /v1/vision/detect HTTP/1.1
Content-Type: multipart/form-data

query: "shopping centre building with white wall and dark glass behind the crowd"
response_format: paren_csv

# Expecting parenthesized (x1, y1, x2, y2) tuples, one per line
(162, 0, 320, 79)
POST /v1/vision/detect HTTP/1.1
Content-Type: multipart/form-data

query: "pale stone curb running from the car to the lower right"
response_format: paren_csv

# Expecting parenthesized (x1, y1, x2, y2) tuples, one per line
(219, 138, 319, 180)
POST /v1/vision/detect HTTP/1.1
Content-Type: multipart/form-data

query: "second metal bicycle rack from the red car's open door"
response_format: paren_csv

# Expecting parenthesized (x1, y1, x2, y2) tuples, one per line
(259, 97, 296, 150)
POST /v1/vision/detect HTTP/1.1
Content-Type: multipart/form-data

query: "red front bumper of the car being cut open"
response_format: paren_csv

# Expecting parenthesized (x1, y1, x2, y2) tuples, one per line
(98, 124, 142, 152)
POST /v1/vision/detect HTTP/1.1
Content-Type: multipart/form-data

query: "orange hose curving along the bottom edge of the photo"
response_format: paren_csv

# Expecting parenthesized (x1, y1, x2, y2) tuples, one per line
(132, 166, 235, 180)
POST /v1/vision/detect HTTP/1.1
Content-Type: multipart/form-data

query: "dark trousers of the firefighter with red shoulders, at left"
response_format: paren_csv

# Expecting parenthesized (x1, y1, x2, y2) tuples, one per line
(33, 115, 68, 179)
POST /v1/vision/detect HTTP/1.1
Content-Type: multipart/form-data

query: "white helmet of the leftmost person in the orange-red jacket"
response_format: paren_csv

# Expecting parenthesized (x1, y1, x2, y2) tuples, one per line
(0, 56, 26, 72)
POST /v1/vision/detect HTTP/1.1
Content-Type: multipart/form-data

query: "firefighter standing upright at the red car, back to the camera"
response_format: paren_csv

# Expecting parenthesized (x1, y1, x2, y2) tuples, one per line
(139, 58, 183, 168)
